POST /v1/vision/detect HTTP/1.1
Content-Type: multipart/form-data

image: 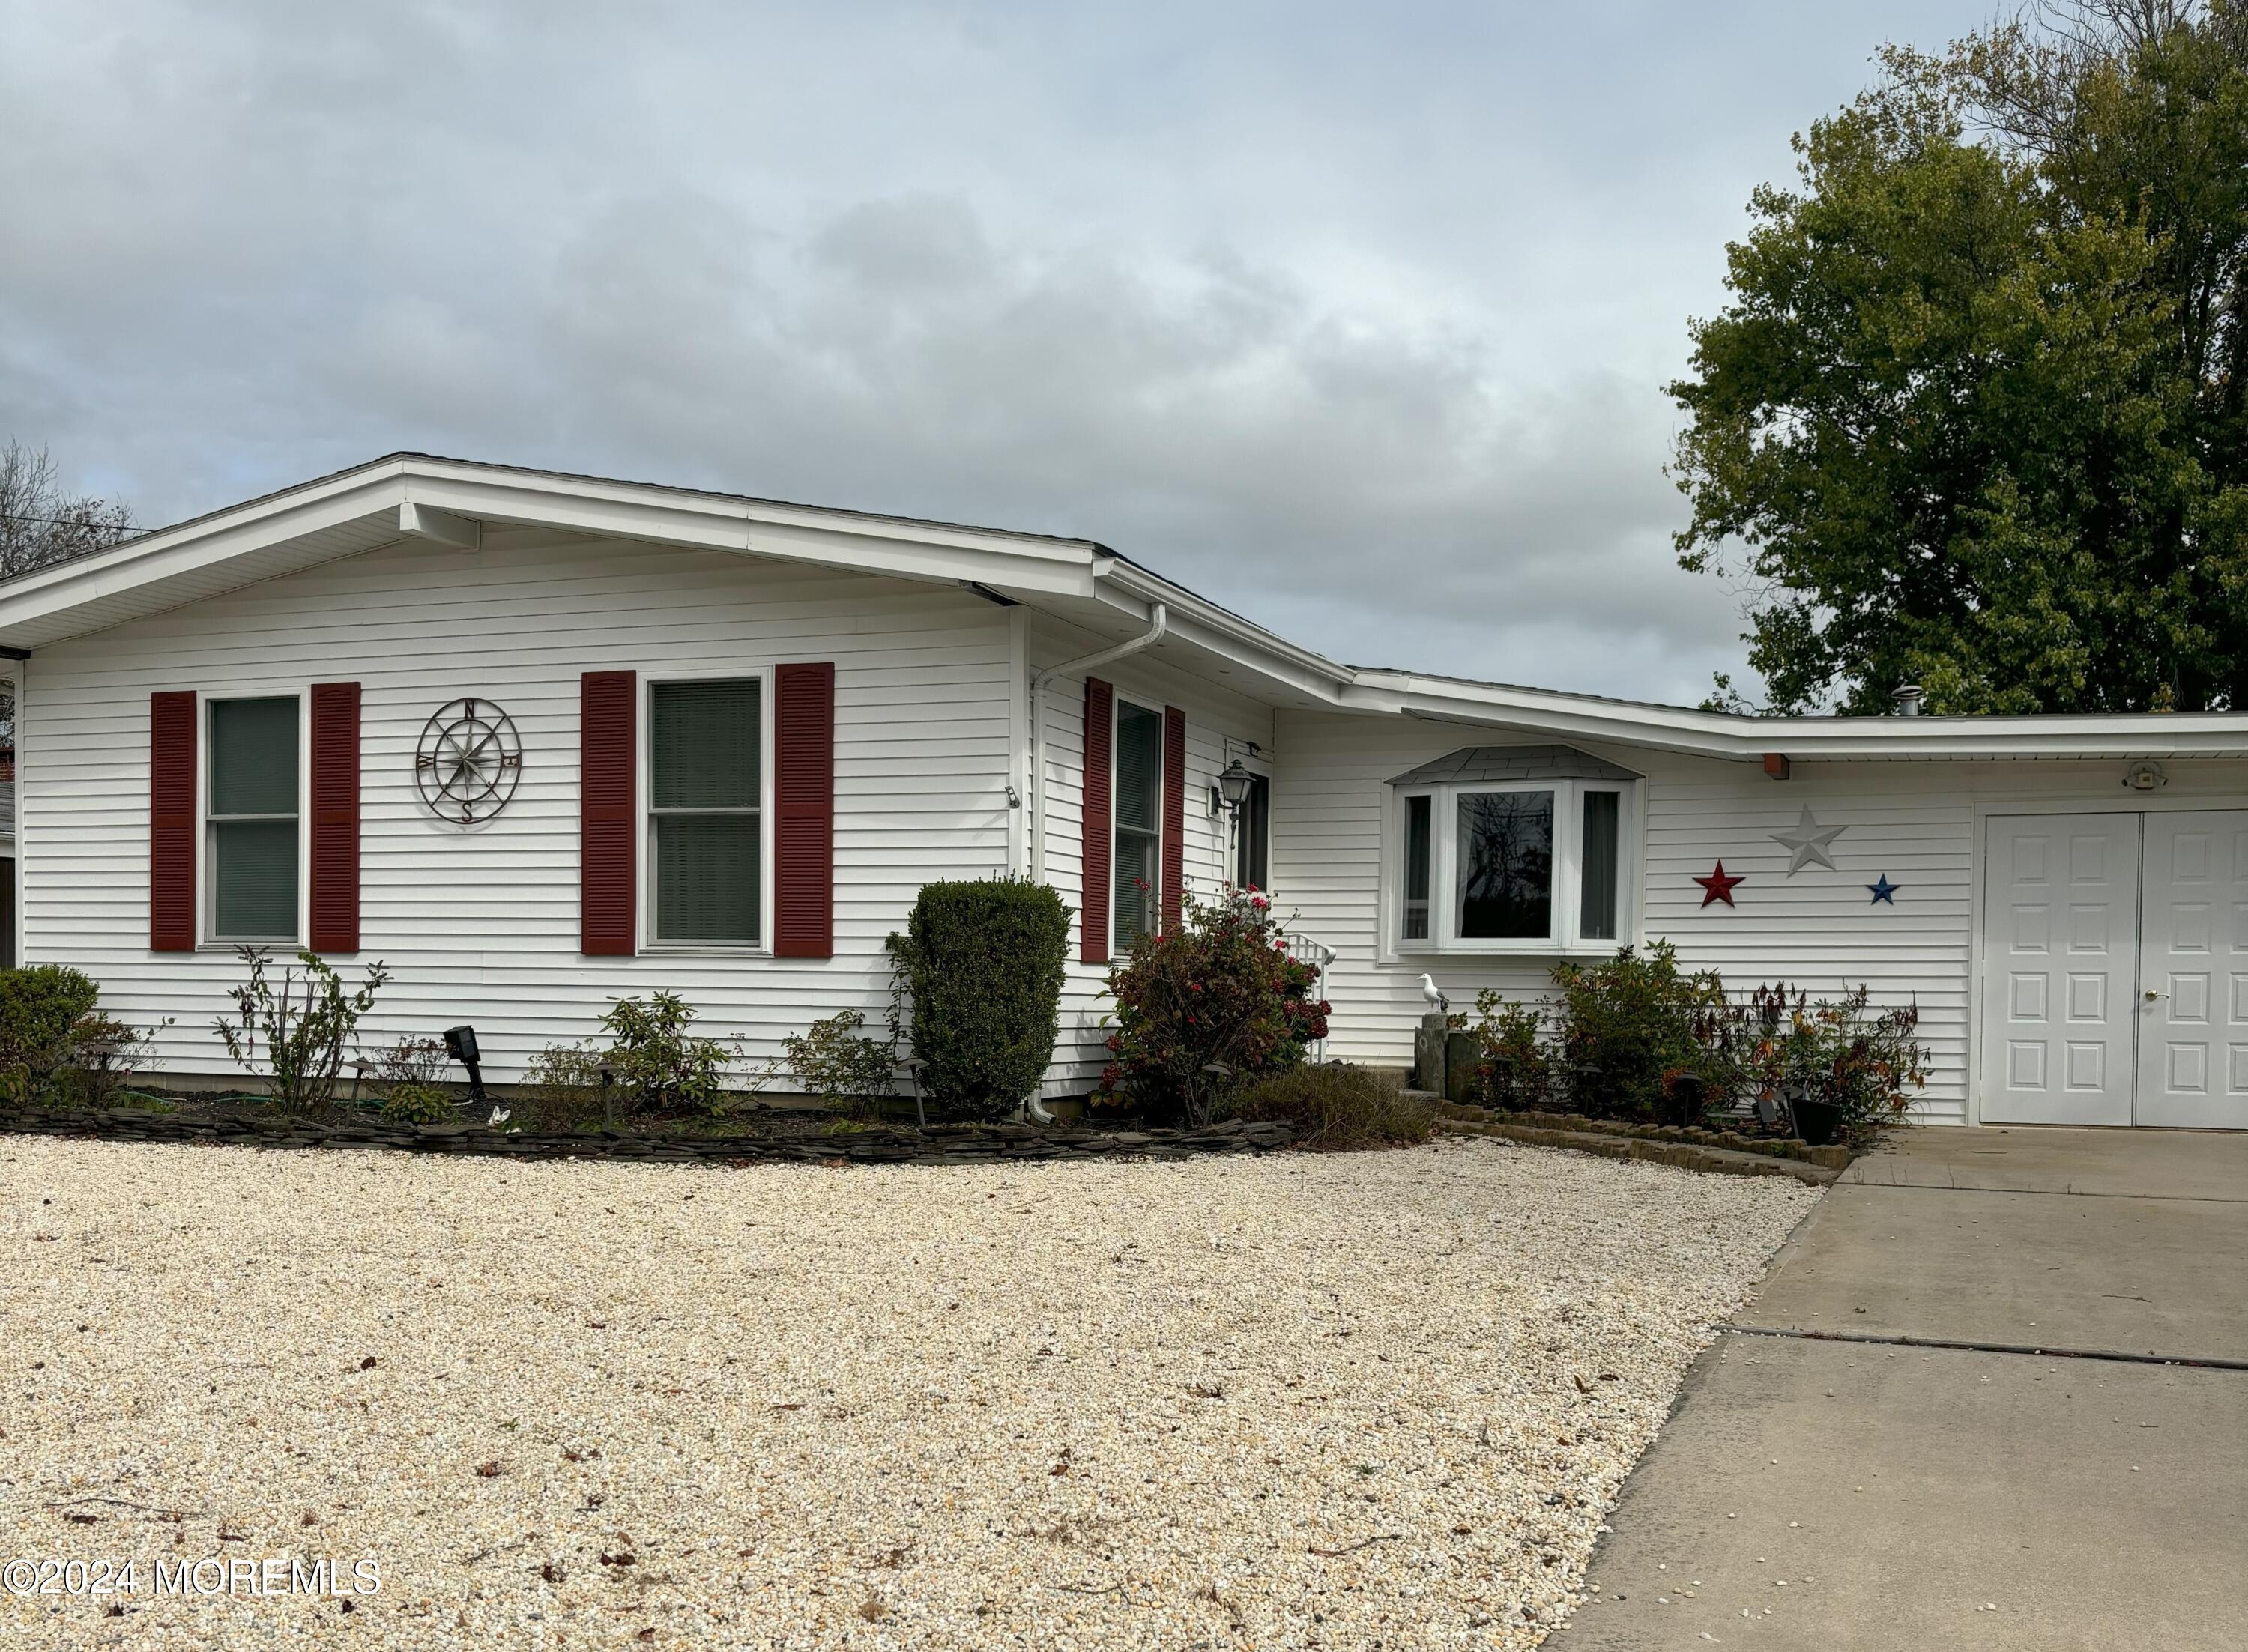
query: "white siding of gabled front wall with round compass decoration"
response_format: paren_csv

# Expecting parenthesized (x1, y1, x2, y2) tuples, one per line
(22, 528, 1018, 1081)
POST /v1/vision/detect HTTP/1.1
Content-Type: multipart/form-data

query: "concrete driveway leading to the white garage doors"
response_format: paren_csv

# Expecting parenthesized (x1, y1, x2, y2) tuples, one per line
(1549, 1128, 2248, 1652)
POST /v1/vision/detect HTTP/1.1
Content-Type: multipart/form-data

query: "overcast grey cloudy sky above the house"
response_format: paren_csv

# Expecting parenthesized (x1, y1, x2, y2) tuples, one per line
(0, 0, 1989, 704)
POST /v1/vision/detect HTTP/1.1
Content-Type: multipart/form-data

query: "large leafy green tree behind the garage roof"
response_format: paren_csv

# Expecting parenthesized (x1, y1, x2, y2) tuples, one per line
(1670, 0, 2248, 712)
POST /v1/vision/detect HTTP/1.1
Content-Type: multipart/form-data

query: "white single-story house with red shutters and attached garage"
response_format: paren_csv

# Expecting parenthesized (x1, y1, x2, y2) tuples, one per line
(0, 454, 2248, 1128)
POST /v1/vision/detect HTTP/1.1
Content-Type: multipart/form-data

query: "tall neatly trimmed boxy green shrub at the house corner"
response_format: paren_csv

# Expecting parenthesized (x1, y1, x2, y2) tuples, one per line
(890, 877, 1070, 1119)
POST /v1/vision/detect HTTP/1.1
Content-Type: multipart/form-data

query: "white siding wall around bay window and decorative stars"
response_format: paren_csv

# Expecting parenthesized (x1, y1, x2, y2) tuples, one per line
(1272, 712, 2241, 1119)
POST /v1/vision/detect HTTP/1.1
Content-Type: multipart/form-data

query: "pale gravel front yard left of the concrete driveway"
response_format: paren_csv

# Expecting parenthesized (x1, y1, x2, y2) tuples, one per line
(0, 1137, 1816, 1652)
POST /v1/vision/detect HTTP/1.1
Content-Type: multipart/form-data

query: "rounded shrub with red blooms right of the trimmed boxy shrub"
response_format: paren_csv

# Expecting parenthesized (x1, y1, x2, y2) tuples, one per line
(1102, 886, 1326, 1124)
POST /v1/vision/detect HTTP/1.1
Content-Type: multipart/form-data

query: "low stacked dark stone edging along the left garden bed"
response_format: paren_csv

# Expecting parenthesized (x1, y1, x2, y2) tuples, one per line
(0, 1108, 1295, 1164)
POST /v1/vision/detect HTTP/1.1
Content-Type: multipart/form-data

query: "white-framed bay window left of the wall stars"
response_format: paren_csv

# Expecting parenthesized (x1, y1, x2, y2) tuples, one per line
(1387, 780, 1639, 953)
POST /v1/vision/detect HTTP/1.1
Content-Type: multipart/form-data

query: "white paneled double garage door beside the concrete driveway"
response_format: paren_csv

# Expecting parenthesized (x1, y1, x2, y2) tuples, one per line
(1980, 809, 2248, 1128)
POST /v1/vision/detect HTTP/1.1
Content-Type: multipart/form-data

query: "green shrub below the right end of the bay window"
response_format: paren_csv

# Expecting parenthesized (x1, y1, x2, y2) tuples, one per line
(1553, 942, 1733, 1119)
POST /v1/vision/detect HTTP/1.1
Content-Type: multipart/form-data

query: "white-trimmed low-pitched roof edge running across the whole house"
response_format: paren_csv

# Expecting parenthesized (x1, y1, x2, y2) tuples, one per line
(0, 452, 2248, 762)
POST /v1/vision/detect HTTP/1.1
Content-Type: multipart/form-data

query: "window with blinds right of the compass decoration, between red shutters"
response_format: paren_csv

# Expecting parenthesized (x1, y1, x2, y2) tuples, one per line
(647, 677, 764, 946)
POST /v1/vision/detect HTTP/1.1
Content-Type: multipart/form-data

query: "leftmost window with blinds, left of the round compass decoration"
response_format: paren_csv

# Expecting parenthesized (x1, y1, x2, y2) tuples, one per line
(205, 695, 297, 942)
